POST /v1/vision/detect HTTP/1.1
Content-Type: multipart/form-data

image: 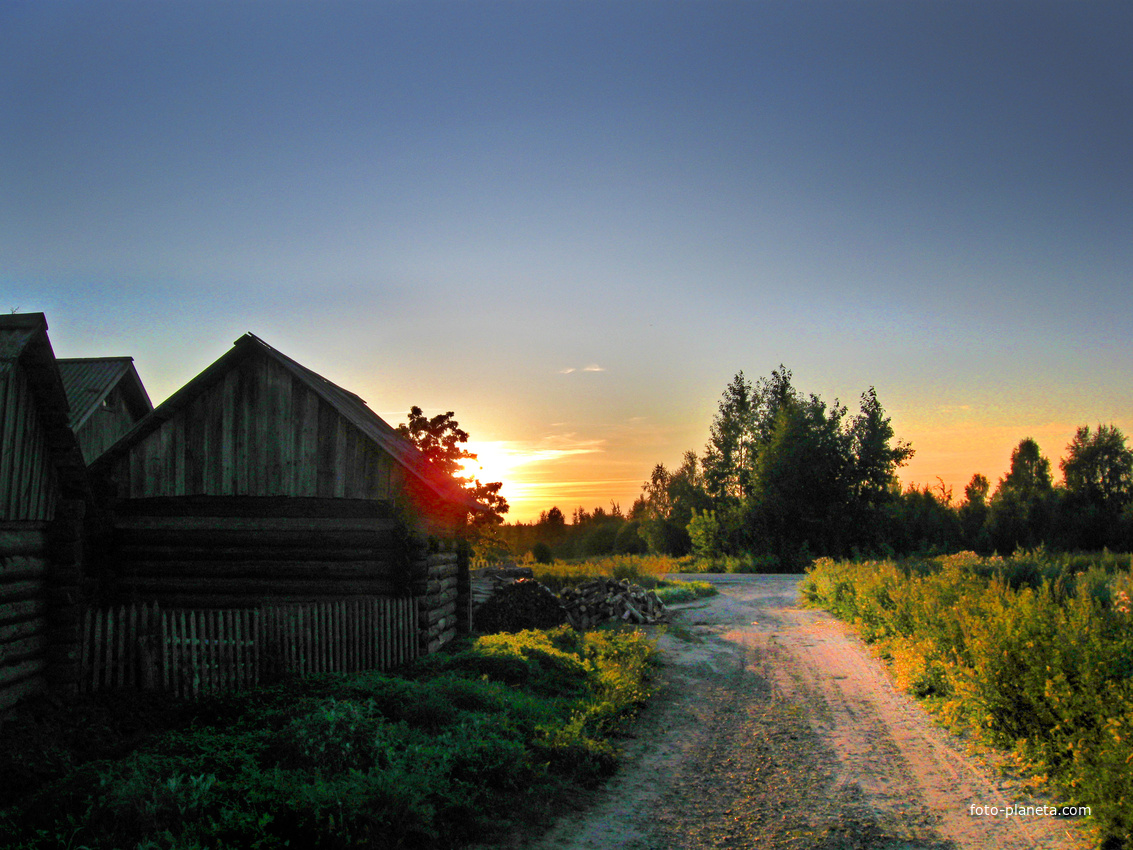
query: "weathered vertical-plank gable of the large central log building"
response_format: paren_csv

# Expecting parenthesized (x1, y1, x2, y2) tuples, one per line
(103, 346, 400, 500)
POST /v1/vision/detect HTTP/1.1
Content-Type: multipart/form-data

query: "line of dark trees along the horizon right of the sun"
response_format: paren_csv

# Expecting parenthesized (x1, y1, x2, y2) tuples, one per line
(496, 366, 1133, 571)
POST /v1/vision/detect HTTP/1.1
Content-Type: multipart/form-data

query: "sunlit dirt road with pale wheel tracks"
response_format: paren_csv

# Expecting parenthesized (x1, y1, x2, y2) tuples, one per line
(538, 576, 1090, 850)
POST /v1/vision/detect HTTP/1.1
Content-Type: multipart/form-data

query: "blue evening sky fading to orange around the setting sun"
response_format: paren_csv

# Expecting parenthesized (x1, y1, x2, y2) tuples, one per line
(0, 0, 1133, 521)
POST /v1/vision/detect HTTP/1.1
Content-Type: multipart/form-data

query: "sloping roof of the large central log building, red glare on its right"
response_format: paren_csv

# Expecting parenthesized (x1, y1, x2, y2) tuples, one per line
(92, 333, 487, 512)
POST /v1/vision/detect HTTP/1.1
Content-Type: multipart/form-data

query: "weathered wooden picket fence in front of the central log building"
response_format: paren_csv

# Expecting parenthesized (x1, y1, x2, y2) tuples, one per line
(79, 596, 419, 697)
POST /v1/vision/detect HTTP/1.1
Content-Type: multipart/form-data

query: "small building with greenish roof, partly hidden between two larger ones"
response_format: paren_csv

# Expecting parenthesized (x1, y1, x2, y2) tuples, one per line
(56, 357, 153, 464)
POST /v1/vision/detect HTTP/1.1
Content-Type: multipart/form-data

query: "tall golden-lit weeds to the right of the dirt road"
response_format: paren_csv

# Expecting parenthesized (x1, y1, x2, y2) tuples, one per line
(802, 551, 1133, 847)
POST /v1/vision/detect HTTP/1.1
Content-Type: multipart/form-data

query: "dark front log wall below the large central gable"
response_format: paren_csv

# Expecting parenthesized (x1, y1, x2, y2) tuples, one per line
(103, 496, 424, 609)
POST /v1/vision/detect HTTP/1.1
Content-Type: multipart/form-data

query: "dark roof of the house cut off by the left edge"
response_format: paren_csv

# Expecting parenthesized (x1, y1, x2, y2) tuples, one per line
(0, 313, 91, 501)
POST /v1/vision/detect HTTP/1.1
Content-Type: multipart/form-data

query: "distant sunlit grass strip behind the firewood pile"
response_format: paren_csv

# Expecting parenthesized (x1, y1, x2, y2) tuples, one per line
(525, 555, 716, 604)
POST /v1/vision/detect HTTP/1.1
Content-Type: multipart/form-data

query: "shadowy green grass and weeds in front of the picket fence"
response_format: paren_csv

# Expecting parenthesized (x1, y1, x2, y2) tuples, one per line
(0, 628, 655, 850)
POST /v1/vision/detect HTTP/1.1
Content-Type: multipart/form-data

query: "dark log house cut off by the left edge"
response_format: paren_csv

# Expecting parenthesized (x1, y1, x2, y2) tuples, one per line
(0, 313, 91, 709)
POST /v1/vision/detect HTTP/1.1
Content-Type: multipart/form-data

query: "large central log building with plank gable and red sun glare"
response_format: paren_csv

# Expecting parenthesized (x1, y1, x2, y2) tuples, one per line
(91, 333, 484, 651)
